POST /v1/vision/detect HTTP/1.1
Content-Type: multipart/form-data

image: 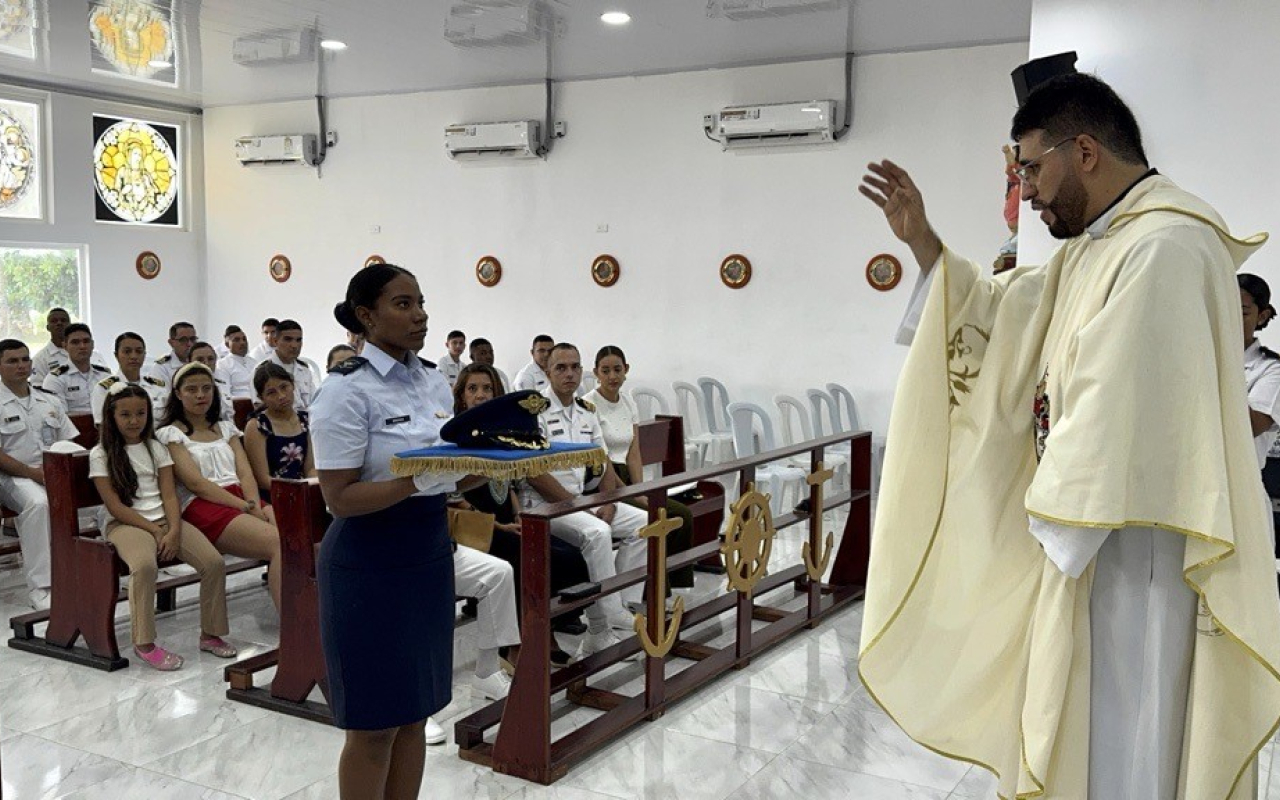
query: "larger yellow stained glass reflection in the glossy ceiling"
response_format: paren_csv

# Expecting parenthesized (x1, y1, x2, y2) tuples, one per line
(88, 0, 178, 86)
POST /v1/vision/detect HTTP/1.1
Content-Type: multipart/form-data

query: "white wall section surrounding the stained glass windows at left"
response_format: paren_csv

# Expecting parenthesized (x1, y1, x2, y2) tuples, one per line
(0, 87, 205, 365)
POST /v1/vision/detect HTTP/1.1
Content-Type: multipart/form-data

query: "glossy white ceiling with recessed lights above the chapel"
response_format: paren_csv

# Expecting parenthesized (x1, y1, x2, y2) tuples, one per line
(0, 0, 1032, 108)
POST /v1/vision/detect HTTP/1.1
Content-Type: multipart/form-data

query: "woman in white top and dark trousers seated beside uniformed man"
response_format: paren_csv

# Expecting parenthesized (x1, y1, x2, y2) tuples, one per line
(582, 344, 694, 589)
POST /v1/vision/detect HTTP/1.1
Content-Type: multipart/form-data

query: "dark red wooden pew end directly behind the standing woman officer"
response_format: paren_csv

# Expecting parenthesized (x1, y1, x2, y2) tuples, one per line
(223, 477, 333, 723)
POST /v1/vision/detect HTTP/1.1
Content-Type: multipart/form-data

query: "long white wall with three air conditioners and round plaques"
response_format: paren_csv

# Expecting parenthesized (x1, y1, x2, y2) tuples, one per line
(205, 45, 1027, 431)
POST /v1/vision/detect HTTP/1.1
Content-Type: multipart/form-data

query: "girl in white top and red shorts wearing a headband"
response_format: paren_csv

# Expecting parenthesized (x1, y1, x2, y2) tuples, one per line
(156, 361, 280, 609)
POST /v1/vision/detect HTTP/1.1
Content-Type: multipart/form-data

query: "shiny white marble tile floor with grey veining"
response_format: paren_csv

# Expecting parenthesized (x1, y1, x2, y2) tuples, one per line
(0, 514, 1280, 800)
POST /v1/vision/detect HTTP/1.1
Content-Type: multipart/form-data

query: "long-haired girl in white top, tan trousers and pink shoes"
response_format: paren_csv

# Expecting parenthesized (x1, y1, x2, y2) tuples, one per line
(88, 381, 237, 671)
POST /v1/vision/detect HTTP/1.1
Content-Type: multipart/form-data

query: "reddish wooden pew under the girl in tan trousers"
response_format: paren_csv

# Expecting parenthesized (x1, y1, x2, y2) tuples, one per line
(9, 453, 265, 672)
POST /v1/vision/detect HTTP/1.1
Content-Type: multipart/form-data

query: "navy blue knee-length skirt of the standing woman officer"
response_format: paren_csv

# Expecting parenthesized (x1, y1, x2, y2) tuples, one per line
(316, 494, 454, 731)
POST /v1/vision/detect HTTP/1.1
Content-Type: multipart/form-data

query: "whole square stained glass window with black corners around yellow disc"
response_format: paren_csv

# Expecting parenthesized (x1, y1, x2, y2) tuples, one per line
(93, 114, 180, 225)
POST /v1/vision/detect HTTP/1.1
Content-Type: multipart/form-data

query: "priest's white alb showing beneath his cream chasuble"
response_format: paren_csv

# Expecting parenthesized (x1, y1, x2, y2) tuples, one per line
(895, 197, 1203, 800)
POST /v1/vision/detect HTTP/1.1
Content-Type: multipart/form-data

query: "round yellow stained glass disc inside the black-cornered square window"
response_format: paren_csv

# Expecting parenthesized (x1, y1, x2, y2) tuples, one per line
(93, 119, 178, 223)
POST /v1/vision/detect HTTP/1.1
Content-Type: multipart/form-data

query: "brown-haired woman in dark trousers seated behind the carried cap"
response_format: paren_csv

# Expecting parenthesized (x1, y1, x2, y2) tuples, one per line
(453, 364, 588, 663)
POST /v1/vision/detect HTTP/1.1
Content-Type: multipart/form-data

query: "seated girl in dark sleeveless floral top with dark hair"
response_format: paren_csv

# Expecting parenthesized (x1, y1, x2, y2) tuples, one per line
(244, 361, 316, 503)
